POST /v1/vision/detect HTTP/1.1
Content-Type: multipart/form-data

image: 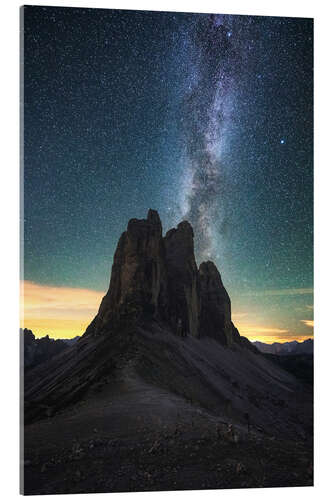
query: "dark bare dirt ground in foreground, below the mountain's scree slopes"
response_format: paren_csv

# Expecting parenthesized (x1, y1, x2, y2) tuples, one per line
(24, 374, 313, 495)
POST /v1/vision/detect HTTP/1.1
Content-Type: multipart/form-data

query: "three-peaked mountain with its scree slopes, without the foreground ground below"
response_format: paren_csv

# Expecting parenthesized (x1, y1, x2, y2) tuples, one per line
(25, 210, 311, 442)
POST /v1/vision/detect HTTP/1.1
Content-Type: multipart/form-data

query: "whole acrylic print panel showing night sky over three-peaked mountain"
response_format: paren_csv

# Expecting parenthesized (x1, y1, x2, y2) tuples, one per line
(20, 6, 313, 494)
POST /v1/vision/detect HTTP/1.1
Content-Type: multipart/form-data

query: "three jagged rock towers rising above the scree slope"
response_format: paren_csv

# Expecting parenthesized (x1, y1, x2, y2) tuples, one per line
(85, 209, 256, 350)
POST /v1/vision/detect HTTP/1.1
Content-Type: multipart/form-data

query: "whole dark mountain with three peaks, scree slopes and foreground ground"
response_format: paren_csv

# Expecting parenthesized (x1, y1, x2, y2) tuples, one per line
(22, 210, 313, 494)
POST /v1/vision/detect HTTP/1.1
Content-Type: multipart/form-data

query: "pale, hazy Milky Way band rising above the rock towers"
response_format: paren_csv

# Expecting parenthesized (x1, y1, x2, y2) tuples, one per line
(178, 16, 241, 259)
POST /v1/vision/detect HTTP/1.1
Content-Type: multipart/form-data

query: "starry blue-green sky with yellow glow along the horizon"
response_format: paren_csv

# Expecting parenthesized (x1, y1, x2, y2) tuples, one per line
(22, 6, 313, 342)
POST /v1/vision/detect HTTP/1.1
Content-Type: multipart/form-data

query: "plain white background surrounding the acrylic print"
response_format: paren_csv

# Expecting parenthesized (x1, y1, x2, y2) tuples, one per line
(0, 0, 333, 500)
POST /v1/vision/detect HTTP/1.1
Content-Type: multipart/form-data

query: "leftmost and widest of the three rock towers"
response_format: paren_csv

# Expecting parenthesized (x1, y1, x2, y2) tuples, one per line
(88, 210, 167, 333)
